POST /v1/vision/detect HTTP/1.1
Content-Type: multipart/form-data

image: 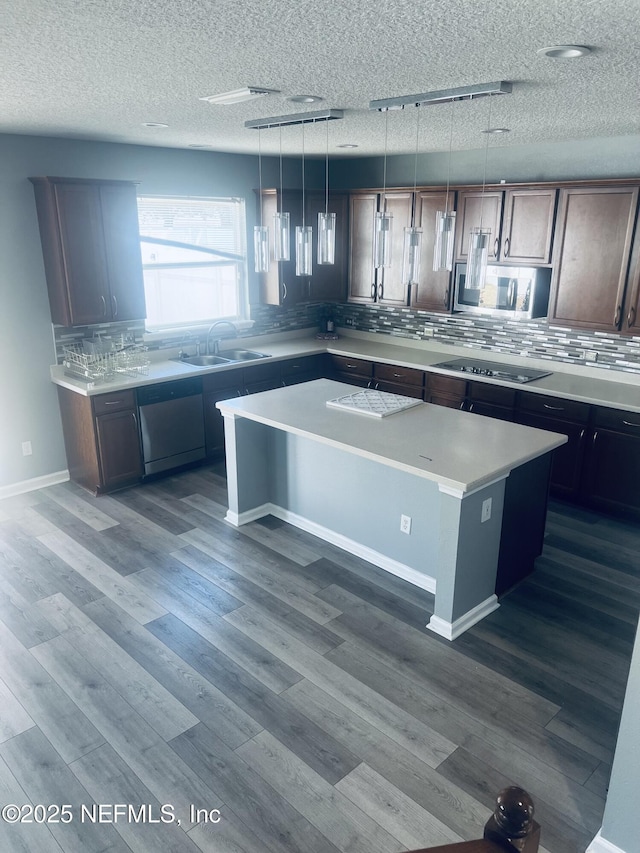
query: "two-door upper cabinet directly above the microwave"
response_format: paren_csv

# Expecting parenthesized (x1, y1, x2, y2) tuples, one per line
(456, 187, 558, 266)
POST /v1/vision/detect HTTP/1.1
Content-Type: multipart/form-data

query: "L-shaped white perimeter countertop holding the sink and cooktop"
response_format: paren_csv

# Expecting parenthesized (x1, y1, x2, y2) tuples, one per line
(51, 332, 640, 412)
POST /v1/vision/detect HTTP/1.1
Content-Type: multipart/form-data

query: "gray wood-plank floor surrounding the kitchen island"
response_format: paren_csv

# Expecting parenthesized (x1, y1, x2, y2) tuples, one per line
(0, 467, 640, 853)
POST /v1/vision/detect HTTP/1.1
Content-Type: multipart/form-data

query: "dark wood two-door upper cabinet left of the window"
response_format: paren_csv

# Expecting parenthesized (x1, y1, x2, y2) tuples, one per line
(31, 178, 146, 326)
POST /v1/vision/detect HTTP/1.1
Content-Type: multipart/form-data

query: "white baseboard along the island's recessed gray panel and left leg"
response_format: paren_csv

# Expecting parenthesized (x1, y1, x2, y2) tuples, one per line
(225, 503, 436, 593)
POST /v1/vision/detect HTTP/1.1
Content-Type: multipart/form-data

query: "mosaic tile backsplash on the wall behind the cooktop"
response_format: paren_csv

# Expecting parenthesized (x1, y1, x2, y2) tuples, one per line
(333, 303, 640, 374)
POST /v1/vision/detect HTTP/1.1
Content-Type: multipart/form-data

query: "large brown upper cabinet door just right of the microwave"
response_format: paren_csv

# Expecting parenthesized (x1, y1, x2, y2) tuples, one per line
(549, 187, 638, 331)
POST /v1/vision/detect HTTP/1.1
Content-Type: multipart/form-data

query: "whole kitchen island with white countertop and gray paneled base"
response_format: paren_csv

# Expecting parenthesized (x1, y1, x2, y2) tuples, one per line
(217, 379, 566, 640)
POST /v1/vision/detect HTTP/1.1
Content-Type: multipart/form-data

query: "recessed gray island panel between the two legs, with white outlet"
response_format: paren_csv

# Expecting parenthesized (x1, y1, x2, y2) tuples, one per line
(272, 430, 440, 591)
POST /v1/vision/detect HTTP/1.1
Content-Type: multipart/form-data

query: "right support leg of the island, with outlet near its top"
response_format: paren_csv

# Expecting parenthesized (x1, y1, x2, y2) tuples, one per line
(427, 479, 505, 640)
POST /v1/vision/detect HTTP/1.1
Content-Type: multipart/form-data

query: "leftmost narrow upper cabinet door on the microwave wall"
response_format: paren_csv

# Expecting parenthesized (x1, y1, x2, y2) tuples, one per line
(349, 193, 378, 302)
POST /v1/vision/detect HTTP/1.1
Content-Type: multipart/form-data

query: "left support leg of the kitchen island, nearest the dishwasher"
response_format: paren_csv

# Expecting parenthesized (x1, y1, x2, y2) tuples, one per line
(224, 413, 273, 526)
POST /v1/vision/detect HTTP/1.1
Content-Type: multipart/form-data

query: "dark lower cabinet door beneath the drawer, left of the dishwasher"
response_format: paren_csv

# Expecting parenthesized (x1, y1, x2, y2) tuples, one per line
(95, 410, 142, 491)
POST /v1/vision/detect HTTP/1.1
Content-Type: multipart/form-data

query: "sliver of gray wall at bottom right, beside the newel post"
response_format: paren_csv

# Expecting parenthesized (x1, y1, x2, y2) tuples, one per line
(601, 620, 640, 853)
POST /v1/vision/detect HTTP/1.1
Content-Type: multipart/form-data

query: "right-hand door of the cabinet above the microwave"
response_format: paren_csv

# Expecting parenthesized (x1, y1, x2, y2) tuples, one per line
(500, 189, 558, 264)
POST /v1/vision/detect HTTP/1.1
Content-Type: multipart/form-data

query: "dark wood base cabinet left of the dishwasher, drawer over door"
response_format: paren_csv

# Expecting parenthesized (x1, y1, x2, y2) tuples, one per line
(58, 387, 142, 494)
